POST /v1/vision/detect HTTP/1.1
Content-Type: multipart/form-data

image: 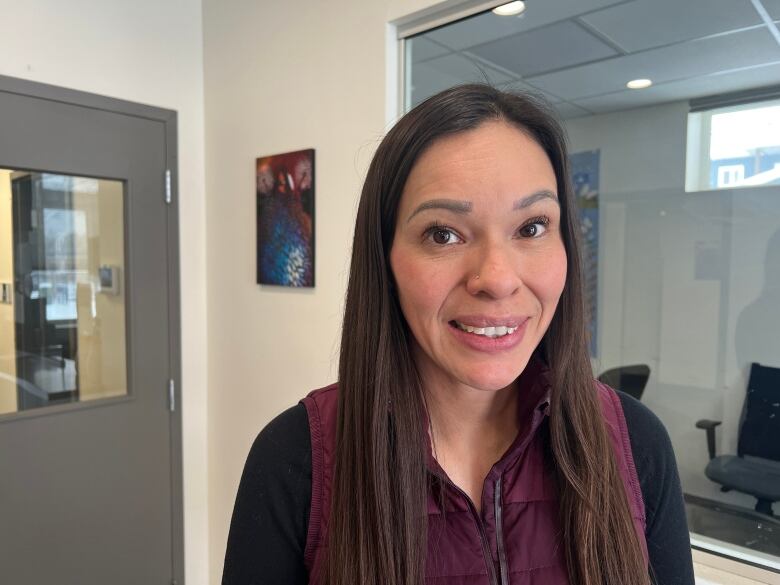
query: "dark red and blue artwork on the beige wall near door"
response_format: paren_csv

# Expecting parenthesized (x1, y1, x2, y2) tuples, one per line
(255, 148, 314, 287)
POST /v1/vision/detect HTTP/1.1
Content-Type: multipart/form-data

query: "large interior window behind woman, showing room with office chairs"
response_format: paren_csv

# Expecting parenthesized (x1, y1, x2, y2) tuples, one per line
(403, 0, 780, 570)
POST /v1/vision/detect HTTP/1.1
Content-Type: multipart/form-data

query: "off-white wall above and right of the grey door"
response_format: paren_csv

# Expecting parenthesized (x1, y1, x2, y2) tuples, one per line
(0, 0, 208, 585)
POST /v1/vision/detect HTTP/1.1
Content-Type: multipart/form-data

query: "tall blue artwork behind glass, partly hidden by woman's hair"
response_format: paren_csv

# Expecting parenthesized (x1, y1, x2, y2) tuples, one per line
(569, 150, 599, 358)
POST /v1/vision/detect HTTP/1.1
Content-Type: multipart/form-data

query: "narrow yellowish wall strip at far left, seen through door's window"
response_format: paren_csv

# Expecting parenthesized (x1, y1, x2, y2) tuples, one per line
(0, 169, 17, 414)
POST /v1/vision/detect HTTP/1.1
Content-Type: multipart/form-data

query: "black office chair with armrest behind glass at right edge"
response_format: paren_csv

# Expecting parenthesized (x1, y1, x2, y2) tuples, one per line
(696, 363, 780, 516)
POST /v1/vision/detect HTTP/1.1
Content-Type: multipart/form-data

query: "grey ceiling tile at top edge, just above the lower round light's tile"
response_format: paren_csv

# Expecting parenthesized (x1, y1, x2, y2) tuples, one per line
(582, 0, 760, 53)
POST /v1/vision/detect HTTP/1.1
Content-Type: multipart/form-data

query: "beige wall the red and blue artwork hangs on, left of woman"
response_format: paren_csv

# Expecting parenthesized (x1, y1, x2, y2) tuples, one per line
(204, 0, 455, 583)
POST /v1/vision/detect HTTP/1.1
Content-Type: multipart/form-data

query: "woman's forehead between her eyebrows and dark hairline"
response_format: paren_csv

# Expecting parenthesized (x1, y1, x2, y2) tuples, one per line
(401, 121, 556, 208)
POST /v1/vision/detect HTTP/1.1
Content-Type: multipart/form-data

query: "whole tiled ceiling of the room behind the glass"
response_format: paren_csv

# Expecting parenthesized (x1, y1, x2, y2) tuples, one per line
(409, 0, 780, 118)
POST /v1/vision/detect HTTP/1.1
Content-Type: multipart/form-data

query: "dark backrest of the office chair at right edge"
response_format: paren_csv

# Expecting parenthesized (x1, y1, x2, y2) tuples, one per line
(737, 363, 780, 461)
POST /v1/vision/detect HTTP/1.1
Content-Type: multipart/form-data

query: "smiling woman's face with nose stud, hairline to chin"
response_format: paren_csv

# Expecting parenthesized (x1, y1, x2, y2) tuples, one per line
(390, 121, 566, 390)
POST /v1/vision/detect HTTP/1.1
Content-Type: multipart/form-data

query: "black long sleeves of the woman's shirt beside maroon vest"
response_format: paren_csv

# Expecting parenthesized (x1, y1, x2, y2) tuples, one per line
(222, 392, 694, 585)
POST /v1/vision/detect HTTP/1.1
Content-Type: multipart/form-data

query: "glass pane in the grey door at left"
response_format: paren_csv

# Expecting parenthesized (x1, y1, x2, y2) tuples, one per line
(0, 169, 127, 415)
